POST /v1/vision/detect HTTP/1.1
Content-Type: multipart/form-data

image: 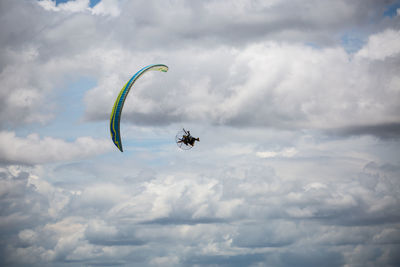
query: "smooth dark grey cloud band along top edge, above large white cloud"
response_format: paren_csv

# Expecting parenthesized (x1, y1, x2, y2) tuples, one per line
(110, 1, 400, 49)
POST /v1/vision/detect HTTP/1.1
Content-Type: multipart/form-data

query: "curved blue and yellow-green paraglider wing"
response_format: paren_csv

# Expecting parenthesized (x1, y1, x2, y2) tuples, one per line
(110, 64, 168, 152)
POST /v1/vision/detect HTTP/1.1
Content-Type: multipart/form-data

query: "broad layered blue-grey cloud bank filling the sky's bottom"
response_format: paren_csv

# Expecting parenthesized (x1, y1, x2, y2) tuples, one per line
(0, 154, 400, 266)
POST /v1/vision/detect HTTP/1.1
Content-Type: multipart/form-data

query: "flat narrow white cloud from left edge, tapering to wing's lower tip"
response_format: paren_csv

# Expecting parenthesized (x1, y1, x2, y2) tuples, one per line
(0, 131, 111, 164)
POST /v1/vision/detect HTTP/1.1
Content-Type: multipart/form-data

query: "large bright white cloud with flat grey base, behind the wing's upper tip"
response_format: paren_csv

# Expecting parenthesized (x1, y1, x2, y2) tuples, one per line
(77, 42, 399, 140)
